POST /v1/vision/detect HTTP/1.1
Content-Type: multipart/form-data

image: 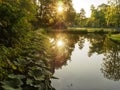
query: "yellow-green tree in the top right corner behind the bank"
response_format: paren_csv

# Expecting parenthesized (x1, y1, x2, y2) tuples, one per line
(106, 0, 120, 27)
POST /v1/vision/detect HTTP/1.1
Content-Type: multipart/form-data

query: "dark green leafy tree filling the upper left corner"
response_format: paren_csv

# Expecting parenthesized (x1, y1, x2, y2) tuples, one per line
(0, 0, 35, 47)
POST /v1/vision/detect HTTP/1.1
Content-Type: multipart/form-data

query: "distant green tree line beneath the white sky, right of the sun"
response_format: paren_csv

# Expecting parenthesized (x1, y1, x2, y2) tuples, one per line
(75, 0, 120, 28)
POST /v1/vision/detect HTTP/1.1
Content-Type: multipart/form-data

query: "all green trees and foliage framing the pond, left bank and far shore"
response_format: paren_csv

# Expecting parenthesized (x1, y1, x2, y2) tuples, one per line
(0, 0, 120, 90)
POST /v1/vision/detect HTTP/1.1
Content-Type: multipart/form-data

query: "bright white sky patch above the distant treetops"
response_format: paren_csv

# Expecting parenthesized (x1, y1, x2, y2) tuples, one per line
(72, 0, 108, 17)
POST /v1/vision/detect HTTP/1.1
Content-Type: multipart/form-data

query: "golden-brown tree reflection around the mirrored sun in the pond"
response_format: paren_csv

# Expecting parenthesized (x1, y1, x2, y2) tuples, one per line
(49, 33, 79, 73)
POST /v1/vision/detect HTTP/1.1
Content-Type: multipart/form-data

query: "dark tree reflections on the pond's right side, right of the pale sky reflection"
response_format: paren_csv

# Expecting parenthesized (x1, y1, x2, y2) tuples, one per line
(80, 34, 120, 80)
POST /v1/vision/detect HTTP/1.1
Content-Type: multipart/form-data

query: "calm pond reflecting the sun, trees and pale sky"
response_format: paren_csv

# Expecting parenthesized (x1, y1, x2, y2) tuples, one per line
(49, 33, 120, 90)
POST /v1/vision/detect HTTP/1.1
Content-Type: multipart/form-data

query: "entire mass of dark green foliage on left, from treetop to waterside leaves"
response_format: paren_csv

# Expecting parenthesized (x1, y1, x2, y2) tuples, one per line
(0, 0, 52, 90)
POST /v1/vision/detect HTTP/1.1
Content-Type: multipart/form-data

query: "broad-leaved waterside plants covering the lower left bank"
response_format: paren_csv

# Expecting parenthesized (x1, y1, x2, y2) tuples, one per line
(0, 32, 52, 90)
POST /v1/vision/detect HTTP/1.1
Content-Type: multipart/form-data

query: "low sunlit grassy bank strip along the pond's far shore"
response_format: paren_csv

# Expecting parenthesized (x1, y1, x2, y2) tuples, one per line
(47, 28, 120, 34)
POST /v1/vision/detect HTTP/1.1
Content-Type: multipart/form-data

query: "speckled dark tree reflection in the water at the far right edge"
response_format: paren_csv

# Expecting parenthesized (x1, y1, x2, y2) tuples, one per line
(101, 38, 120, 81)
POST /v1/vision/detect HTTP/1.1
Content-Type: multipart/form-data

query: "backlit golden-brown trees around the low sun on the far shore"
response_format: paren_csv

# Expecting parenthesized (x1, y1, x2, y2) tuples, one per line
(36, 0, 75, 28)
